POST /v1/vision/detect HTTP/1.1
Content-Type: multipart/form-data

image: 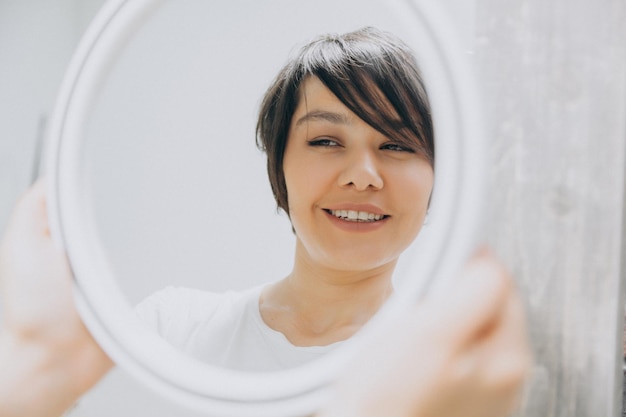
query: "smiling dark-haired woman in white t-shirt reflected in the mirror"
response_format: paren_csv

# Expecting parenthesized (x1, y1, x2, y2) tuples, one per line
(138, 28, 434, 371)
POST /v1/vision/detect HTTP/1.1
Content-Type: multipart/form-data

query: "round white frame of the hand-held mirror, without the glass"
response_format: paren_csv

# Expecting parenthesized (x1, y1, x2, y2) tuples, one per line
(46, 0, 487, 417)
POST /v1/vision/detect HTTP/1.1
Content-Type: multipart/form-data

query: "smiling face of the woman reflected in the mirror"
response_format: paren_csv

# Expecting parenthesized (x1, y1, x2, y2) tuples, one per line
(283, 77, 433, 271)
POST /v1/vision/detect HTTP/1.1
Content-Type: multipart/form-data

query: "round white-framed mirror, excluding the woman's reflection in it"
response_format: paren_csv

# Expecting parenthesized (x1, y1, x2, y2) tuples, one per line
(48, 0, 484, 416)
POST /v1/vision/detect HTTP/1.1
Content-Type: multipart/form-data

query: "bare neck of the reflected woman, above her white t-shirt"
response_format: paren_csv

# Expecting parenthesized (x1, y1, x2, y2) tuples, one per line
(259, 240, 396, 346)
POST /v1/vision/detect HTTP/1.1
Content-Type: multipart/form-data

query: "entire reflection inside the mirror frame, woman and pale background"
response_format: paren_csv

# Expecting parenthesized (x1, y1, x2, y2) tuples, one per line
(85, 1, 434, 371)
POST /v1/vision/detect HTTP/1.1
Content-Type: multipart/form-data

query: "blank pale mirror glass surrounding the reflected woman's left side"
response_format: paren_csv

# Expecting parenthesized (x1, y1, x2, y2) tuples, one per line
(84, 0, 442, 358)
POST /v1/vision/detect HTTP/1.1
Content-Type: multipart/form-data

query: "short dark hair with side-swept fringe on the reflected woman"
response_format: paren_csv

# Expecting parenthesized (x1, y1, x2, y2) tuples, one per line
(256, 27, 435, 214)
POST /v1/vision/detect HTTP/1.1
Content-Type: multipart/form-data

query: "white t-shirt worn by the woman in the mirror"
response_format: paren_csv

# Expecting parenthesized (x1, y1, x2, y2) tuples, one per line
(136, 286, 341, 372)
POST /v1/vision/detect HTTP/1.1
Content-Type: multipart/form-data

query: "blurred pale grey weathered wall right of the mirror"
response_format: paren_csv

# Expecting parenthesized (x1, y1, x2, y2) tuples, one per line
(475, 0, 626, 417)
